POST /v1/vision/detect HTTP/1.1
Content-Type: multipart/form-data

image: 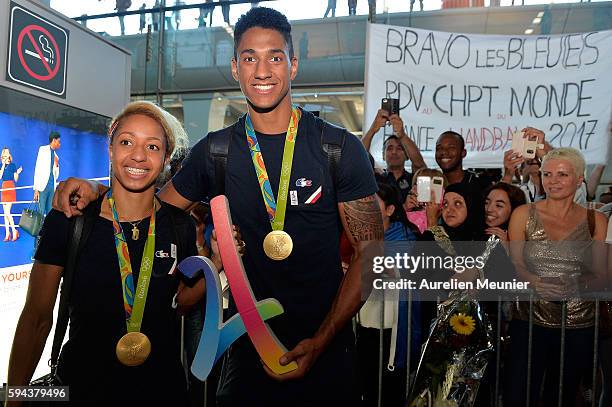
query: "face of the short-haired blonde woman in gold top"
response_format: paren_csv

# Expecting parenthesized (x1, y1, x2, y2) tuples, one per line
(542, 158, 583, 199)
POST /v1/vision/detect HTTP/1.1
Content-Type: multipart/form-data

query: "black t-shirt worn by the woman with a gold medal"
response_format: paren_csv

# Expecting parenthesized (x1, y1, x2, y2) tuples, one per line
(35, 204, 197, 405)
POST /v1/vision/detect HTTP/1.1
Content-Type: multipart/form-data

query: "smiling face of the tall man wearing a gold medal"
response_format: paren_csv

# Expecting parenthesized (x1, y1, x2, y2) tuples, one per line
(232, 27, 298, 112)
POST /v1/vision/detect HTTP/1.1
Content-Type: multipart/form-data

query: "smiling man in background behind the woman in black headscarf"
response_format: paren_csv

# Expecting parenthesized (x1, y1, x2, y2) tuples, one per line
(436, 130, 494, 192)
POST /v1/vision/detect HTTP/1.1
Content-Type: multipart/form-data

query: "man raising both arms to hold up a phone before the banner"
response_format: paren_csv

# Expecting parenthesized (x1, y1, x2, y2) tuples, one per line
(361, 109, 426, 202)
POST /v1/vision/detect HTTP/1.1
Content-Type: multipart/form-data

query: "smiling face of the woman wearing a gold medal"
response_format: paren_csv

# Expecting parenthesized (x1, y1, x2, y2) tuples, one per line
(109, 114, 166, 192)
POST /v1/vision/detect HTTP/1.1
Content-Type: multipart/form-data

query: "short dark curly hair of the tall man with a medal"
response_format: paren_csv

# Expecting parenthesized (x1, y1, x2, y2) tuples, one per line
(234, 7, 294, 58)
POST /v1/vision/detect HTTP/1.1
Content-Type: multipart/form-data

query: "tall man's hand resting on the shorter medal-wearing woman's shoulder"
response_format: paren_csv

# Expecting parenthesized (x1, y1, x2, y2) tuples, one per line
(53, 177, 100, 218)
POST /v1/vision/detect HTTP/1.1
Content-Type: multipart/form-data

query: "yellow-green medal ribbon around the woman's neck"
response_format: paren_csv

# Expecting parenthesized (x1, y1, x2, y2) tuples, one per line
(106, 190, 155, 332)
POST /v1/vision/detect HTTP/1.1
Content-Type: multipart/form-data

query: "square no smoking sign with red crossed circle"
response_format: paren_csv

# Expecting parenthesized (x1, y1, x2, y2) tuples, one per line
(7, 3, 68, 99)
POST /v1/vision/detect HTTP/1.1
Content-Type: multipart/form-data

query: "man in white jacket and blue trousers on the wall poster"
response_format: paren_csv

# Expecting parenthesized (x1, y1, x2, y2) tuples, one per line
(34, 131, 60, 216)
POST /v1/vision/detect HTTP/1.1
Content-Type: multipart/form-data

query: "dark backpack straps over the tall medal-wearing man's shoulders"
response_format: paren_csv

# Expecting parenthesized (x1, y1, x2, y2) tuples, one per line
(206, 111, 347, 199)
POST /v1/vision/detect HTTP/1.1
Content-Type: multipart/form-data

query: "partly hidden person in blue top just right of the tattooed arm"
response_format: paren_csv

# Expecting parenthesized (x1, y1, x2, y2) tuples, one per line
(357, 182, 421, 407)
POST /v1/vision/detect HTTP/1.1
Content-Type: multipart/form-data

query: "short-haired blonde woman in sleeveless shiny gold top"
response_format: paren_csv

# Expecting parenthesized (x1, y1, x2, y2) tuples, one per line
(504, 148, 606, 406)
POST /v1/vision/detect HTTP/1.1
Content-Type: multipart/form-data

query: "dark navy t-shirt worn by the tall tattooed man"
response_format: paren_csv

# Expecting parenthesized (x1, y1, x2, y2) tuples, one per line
(172, 111, 377, 349)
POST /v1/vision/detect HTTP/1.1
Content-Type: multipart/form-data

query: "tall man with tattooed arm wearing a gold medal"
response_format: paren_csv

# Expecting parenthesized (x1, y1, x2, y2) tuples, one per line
(56, 7, 383, 406)
